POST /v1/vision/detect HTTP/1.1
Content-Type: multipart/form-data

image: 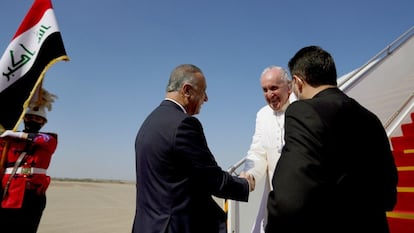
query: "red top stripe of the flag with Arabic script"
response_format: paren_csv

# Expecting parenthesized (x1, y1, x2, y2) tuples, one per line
(12, 0, 53, 40)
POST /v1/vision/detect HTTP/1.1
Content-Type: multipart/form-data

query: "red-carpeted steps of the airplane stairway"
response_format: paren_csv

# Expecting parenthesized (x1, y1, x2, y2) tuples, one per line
(387, 113, 414, 233)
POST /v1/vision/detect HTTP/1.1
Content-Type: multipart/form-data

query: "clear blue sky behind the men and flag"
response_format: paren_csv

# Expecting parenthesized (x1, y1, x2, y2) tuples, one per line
(0, 0, 414, 181)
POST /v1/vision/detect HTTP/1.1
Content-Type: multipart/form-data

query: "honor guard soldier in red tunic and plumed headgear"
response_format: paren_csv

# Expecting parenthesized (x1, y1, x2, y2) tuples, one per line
(0, 89, 57, 233)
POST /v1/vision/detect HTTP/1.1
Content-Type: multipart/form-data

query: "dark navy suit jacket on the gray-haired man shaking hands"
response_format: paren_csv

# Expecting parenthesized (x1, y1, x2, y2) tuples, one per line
(132, 100, 249, 233)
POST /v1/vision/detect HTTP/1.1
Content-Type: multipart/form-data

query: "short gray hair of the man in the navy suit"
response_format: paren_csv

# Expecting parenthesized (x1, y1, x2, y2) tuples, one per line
(167, 64, 203, 92)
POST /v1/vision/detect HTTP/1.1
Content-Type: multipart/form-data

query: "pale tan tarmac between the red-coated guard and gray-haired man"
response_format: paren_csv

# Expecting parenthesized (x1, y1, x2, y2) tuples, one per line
(38, 178, 135, 233)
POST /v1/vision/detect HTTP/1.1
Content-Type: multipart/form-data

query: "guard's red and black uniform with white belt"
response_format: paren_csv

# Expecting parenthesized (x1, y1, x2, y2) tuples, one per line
(0, 133, 57, 232)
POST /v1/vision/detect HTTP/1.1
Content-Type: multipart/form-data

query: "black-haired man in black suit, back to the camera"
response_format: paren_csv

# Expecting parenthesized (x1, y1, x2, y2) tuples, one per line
(266, 46, 398, 233)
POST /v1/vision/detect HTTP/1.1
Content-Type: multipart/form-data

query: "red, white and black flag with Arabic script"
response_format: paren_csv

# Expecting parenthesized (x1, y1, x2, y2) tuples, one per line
(0, 0, 69, 132)
